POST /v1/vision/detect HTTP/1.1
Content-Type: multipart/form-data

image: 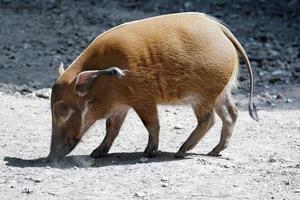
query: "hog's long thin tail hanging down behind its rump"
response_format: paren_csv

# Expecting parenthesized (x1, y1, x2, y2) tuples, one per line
(208, 16, 258, 121)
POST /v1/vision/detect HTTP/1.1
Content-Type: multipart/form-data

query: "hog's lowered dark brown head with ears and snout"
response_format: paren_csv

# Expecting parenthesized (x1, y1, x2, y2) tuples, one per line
(48, 65, 124, 160)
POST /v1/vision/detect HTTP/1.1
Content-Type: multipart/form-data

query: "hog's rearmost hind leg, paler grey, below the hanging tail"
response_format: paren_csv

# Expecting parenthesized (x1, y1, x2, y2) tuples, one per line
(208, 92, 238, 156)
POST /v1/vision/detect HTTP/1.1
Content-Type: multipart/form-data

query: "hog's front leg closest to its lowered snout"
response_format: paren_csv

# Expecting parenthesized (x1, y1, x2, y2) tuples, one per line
(90, 111, 128, 158)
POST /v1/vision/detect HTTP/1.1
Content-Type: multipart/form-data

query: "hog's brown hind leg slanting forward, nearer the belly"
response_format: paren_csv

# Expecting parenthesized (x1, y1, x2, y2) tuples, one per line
(175, 101, 215, 158)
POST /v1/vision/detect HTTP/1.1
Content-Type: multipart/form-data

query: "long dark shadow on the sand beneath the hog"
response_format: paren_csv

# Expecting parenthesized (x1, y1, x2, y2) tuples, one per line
(4, 152, 227, 169)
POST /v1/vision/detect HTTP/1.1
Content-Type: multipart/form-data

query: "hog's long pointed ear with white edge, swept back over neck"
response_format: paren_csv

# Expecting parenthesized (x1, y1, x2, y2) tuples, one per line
(75, 67, 125, 96)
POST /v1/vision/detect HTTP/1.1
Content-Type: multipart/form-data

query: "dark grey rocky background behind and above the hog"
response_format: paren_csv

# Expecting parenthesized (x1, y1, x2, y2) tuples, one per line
(0, 0, 300, 95)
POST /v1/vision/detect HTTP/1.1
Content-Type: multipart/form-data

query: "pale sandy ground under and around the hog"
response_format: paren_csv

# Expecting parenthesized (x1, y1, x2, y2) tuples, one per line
(0, 90, 300, 200)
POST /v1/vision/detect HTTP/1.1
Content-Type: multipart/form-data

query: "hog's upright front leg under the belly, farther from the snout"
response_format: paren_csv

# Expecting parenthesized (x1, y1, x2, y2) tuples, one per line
(133, 103, 160, 157)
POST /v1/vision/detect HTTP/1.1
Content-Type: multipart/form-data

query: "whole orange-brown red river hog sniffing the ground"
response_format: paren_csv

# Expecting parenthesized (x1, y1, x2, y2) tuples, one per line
(48, 13, 257, 160)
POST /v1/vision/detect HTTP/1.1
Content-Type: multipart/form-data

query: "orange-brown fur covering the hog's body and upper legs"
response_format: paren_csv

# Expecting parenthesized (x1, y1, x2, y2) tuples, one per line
(51, 13, 252, 160)
